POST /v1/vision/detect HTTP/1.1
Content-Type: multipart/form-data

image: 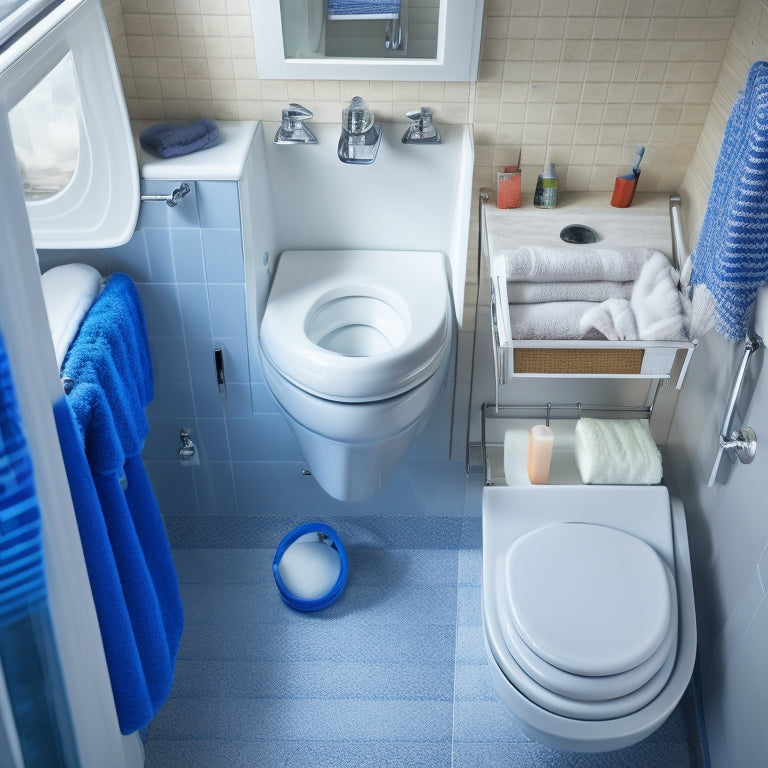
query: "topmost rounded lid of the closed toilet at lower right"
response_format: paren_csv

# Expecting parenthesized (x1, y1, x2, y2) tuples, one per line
(504, 523, 673, 676)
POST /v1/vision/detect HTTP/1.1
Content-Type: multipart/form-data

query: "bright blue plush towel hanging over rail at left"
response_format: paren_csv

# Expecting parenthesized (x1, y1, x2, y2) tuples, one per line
(55, 273, 183, 733)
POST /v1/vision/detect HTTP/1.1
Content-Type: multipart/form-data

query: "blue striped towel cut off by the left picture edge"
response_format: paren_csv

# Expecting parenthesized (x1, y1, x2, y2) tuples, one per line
(0, 328, 46, 627)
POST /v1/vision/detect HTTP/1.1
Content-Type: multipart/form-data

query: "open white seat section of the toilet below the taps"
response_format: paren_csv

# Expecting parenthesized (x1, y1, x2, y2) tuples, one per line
(259, 251, 452, 402)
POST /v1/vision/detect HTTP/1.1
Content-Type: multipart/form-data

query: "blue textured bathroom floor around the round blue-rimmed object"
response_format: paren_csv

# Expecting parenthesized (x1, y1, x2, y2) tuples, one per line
(146, 517, 701, 768)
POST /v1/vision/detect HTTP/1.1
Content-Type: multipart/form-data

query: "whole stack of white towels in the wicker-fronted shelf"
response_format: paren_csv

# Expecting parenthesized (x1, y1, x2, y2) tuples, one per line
(492, 246, 690, 341)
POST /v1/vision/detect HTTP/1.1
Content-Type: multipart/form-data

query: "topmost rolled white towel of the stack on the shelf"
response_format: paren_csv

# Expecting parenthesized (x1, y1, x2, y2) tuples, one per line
(494, 246, 660, 283)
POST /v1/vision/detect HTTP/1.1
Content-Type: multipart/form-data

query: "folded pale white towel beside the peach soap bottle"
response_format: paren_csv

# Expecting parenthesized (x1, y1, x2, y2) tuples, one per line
(574, 419, 662, 485)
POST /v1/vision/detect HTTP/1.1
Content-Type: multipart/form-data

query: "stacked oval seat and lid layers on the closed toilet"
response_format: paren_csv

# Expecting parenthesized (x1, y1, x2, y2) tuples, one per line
(486, 522, 677, 720)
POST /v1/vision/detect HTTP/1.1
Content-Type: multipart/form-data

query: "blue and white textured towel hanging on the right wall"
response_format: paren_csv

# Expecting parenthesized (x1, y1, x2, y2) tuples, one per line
(691, 61, 768, 339)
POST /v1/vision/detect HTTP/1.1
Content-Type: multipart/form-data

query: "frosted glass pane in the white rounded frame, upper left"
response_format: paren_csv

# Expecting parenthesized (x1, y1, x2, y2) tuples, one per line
(9, 54, 81, 200)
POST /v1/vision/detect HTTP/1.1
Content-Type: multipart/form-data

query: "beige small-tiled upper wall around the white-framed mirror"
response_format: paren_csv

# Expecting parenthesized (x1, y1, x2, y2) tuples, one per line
(103, 0, 739, 198)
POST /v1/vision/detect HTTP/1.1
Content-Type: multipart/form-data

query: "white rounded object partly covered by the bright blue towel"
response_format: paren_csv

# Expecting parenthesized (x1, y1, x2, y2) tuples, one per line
(41, 264, 103, 369)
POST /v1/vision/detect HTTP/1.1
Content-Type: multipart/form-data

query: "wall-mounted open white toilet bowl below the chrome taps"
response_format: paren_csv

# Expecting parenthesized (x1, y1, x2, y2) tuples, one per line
(259, 250, 454, 501)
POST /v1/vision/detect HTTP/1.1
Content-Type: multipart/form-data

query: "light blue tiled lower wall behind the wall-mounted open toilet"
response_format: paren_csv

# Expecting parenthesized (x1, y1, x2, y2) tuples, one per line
(39, 181, 465, 516)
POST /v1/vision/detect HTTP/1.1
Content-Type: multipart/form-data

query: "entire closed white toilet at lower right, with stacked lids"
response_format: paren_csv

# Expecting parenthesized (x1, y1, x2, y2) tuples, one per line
(483, 485, 696, 752)
